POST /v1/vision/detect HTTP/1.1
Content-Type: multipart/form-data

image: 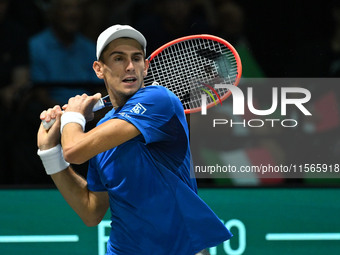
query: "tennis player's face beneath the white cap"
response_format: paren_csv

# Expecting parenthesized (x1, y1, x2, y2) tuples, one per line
(97, 38, 149, 102)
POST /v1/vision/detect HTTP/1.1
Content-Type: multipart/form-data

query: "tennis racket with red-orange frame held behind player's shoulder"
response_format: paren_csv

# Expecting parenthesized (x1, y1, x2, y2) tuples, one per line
(44, 34, 242, 129)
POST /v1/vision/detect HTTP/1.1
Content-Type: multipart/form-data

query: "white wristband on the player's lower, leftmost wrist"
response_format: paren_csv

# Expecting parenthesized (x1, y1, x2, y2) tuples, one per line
(38, 144, 70, 175)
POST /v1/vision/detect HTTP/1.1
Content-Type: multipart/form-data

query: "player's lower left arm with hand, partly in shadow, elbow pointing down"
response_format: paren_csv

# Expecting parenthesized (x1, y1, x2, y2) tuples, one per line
(38, 106, 109, 226)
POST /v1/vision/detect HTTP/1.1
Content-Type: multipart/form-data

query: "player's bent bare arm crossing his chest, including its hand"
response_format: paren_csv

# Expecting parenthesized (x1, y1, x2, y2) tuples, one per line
(61, 95, 140, 164)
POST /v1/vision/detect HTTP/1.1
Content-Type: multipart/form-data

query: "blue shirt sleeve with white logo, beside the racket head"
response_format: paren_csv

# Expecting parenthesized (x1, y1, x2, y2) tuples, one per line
(114, 86, 178, 144)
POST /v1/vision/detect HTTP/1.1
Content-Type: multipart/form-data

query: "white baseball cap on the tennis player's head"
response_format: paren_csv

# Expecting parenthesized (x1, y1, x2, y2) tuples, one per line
(96, 25, 146, 59)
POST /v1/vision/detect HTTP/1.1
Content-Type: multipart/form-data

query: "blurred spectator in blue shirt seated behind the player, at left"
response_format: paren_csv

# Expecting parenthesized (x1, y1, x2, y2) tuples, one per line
(8, 0, 104, 184)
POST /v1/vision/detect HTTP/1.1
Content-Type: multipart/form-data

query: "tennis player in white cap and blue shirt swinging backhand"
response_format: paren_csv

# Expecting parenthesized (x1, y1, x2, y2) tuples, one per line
(38, 25, 232, 255)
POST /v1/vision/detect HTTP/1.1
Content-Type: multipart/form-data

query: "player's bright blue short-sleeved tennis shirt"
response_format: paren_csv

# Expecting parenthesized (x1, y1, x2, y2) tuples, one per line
(87, 86, 232, 255)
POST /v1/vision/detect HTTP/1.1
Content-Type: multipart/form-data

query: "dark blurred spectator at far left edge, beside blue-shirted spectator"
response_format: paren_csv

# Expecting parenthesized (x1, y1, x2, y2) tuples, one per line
(0, 0, 29, 183)
